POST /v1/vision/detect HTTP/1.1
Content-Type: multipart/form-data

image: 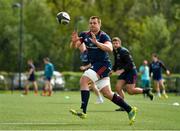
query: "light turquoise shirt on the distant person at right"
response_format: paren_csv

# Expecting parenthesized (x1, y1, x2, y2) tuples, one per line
(139, 65, 150, 80)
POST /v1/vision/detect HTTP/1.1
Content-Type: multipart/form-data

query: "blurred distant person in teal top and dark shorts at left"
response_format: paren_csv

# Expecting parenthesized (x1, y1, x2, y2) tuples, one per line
(42, 57, 54, 96)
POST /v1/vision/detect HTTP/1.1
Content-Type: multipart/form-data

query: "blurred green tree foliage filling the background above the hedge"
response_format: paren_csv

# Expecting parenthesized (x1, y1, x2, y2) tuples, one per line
(0, 0, 180, 73)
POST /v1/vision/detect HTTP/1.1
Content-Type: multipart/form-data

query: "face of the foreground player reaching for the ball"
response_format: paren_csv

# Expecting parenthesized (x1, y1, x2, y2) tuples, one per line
(89, 19, 101, 33)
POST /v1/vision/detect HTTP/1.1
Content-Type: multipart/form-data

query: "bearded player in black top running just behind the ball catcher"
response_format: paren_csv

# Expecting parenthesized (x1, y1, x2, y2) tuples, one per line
(112, 37, 153, 111)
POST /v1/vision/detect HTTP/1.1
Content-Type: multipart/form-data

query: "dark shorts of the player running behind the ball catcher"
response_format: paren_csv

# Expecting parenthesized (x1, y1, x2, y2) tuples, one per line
(118, 69, 137, 84)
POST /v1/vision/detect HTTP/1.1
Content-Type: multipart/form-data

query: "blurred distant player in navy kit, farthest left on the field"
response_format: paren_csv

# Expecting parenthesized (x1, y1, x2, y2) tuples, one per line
(23, 59, 38, 95)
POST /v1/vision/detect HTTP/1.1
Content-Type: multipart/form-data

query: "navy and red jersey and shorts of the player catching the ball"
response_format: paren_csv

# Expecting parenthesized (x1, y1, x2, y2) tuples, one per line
(79, 31, 111, 78)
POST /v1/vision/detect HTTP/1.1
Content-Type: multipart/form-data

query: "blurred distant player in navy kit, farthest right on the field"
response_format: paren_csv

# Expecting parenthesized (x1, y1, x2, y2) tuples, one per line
(150, 53, 170, 99)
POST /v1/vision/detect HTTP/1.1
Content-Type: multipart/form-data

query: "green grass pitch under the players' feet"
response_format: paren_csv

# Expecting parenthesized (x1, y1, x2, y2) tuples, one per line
(0, 92, 180, 130)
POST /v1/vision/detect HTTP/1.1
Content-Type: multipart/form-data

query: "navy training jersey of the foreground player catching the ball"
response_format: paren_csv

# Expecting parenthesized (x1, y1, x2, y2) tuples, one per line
(79, 31, 111, 64)
